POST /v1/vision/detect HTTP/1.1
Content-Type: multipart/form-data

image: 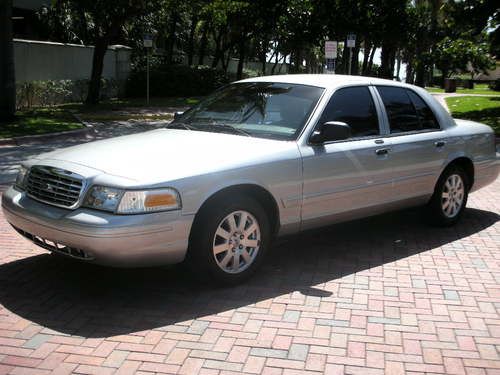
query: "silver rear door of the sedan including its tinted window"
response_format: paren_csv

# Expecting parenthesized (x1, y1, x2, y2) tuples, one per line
(377, 86, 446, 203)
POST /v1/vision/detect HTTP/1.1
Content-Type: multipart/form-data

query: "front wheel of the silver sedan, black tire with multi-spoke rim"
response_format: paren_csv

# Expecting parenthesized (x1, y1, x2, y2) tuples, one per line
(187, 195, 271, 285)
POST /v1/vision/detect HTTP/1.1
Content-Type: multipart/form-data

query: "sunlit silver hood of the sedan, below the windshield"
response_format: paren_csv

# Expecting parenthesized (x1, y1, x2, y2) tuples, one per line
(35, 129, 298, 184)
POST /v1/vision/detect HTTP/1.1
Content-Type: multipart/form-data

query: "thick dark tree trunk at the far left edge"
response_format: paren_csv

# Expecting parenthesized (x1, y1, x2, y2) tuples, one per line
(0, 0, 16, 120)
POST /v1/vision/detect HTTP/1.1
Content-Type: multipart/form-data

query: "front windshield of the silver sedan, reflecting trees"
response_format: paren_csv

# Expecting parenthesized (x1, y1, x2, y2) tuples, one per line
(174, 82, 323, 140)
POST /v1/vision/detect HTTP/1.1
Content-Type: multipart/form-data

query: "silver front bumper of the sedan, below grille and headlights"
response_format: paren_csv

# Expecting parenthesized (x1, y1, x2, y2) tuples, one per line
(2, 188, 194, 267)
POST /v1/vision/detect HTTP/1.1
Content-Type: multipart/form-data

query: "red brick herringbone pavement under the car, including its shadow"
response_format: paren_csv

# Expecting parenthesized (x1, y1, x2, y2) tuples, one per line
(0, 179, 500, 375)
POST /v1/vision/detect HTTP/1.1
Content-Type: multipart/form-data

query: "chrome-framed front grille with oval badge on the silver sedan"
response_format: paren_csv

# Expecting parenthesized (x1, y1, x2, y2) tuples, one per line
(26, 166, 83, 208)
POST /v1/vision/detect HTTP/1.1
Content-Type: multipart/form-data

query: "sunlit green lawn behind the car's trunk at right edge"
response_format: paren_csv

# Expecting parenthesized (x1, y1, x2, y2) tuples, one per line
(446, 96, 500, 136)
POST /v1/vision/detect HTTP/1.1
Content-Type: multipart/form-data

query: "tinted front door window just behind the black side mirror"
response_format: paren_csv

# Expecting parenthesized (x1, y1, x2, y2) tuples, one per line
(320, 86, 379, 137)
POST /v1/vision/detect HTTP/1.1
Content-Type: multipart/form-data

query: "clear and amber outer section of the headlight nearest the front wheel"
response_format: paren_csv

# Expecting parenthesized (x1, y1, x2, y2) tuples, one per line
(117, 189, 181, 214)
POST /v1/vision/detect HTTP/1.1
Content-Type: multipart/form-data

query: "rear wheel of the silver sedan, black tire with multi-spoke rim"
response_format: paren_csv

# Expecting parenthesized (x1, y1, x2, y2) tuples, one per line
(427, 165, 470, 226)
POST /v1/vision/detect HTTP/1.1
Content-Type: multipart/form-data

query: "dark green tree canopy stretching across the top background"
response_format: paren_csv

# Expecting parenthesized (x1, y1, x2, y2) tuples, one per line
(29, 0, 500, 100)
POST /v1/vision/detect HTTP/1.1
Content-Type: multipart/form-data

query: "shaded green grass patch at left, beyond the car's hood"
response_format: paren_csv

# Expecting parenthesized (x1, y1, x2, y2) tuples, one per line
(0, 109, 83, 138)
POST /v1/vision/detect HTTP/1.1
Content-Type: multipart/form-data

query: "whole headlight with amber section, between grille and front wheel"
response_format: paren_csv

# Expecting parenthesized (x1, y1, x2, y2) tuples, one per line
(84, 186, 181, 214)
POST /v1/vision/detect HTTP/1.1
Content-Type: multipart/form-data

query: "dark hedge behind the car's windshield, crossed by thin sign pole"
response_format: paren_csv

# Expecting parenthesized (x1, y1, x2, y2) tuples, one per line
(126, 65, 229, 97)
